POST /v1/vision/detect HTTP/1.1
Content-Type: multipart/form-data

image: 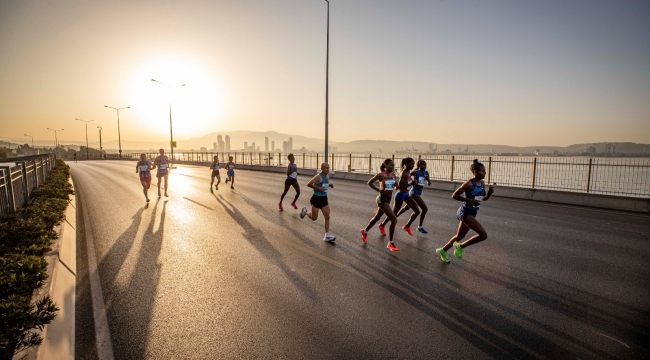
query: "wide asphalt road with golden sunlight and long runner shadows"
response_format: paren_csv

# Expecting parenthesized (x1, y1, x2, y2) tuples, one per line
(69, 161, 650, 359)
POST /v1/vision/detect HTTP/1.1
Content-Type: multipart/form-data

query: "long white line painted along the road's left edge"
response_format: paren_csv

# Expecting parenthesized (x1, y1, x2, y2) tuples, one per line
(76, 181, 114, 360)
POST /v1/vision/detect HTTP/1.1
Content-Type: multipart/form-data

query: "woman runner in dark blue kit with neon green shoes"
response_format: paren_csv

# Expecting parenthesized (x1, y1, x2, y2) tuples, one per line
(436, 159, 494, 262)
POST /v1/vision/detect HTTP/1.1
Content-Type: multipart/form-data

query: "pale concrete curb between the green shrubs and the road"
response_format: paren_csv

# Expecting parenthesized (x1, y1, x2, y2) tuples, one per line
(13, 178, 77, 360)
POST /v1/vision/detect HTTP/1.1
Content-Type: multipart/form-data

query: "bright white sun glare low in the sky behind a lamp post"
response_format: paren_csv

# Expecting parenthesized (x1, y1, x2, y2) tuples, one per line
(129, 57, 224, 140)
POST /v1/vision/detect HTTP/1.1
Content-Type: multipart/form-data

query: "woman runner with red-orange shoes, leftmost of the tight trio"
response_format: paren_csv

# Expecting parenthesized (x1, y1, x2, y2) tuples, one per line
(361, 159, 399, 251)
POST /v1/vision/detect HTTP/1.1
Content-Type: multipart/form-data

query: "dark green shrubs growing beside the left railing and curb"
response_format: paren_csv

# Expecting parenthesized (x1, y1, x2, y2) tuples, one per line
(0, 160, 73, 360)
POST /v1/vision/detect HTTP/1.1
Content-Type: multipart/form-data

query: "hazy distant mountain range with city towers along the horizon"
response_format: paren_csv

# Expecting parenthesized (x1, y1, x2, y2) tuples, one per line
(0, 131, 650, 156)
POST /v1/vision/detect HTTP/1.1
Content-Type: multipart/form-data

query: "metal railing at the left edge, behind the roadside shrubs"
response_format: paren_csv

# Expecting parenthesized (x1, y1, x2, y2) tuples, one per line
(0, 154, 55, 220)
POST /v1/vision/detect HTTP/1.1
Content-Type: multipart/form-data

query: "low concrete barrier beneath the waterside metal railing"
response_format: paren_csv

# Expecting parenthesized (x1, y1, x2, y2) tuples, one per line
(117, 161, 650, 214)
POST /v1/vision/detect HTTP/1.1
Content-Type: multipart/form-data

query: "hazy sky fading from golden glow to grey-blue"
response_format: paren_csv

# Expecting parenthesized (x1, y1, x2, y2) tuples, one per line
(0, 0, 650, 145)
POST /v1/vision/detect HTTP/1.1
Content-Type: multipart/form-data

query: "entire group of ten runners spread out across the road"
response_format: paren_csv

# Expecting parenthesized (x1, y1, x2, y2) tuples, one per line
(136, 149, 494, 263)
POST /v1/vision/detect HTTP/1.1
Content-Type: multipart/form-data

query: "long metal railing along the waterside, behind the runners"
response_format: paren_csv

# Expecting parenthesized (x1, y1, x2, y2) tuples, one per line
(102, 152, 650, 198)
